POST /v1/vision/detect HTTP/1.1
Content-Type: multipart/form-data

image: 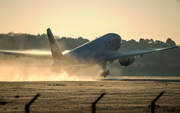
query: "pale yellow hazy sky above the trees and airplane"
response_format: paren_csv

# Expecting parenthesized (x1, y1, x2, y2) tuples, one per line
(0, 0, 180, 44)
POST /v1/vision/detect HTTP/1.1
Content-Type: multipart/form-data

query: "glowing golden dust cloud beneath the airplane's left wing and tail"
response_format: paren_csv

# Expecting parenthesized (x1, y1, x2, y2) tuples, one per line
(0, 54, 101, 81)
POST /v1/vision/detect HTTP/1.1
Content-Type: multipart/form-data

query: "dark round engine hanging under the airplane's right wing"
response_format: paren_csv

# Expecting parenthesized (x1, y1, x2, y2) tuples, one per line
(119, 56, 135, 66)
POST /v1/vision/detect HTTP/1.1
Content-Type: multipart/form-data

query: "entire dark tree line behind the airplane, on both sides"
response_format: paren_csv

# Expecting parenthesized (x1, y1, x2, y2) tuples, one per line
(0, 32, 180, 76)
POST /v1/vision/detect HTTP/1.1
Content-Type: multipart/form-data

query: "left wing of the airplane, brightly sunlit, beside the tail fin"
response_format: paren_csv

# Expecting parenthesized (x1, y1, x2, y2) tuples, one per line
(0, 50, 52, 59)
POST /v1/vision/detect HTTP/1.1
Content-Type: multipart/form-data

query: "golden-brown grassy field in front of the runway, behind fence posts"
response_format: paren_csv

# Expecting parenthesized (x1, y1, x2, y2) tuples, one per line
(0, 77, 180, 113)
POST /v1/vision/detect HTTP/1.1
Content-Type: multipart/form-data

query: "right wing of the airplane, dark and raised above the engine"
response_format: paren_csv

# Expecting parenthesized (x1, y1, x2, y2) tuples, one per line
(106, 46, 177, 61)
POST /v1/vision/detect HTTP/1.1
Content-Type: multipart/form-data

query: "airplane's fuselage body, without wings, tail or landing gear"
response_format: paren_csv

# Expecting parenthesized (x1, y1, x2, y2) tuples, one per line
(64, 33, 121, 64)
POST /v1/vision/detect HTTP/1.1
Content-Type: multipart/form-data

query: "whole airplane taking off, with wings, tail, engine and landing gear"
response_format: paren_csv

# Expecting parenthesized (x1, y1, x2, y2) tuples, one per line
(0, 28, 177, 77)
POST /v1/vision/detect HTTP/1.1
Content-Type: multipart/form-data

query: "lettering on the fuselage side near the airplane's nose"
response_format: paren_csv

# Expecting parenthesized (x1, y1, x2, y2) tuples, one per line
(104, 38, 120, 49)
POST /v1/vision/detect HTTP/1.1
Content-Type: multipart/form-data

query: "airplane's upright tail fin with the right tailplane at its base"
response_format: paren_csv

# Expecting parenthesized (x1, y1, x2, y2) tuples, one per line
(47, 28, 76, 64)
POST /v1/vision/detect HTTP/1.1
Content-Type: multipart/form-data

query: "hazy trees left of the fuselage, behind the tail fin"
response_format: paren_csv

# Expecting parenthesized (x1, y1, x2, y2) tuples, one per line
(0, 32, 89, 51)
